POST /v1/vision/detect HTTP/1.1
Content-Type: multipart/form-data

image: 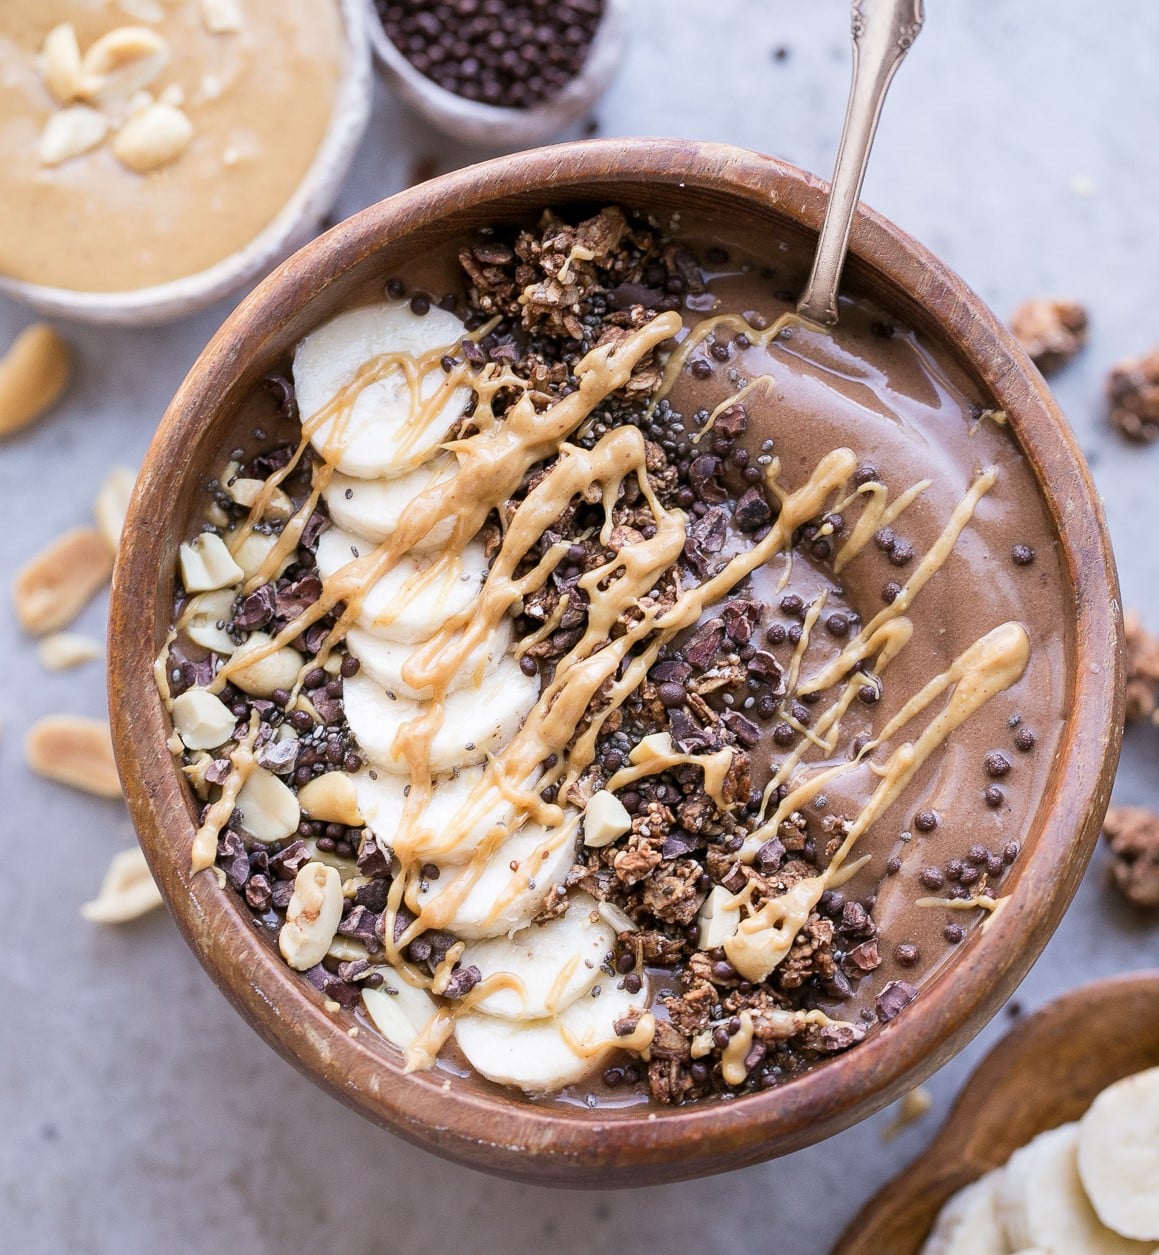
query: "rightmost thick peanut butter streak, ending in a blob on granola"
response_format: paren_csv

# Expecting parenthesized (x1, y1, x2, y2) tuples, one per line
(724, 622, 1030, 981)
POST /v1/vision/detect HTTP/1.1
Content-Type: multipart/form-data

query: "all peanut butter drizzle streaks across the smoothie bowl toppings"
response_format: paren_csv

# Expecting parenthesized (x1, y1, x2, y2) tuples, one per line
(163, 298, 1030, 1064)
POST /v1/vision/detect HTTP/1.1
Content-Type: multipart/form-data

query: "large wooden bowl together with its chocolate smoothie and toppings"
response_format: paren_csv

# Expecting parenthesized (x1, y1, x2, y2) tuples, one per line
(110, 141, 1123, 1185)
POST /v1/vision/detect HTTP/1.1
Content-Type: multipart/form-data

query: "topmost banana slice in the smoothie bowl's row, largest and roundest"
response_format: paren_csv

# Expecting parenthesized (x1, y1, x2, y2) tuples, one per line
(294, 304, 470, 479)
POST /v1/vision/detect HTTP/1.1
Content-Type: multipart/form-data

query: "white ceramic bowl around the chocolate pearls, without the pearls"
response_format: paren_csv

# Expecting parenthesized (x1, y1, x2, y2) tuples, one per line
(366, 0, 628, 151)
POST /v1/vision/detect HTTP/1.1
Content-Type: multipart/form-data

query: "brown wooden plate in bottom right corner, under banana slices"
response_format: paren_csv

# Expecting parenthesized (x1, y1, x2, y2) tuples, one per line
(833, 971, 1159, 1255)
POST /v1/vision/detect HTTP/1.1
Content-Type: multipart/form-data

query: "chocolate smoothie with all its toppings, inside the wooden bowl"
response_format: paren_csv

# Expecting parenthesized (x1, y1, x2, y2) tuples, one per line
(158, 208, 1072, 1103)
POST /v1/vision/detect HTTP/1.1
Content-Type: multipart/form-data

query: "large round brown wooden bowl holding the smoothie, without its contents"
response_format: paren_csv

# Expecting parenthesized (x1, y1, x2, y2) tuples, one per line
(109, 139, 1123, 1186)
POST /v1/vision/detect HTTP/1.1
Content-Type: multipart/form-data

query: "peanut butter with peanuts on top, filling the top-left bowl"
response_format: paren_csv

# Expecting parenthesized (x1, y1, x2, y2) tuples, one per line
(0, 0, 349, 294)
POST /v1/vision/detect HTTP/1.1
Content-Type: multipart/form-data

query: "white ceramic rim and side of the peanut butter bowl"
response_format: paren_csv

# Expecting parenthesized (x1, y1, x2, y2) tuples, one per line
(0, 0, 374, 325)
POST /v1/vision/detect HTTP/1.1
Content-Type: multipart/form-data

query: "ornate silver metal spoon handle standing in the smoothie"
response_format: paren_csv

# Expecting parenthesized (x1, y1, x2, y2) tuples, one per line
(796, 0, 926, 326)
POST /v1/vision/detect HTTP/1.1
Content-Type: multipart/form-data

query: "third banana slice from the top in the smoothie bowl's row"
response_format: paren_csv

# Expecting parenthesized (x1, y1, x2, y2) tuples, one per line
(317, 527, 487, 644)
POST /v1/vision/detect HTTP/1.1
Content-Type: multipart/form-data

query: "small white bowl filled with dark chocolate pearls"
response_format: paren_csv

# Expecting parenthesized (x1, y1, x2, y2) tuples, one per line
(370, 0, 626, 149)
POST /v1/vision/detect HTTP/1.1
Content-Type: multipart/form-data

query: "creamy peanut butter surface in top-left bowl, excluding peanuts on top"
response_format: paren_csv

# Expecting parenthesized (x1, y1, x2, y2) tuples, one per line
(0, 0, 344, 292)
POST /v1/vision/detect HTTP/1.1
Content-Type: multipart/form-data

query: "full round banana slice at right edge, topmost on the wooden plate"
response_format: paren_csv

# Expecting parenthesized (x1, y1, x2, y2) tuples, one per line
(1079, 1068, 1159, 1242)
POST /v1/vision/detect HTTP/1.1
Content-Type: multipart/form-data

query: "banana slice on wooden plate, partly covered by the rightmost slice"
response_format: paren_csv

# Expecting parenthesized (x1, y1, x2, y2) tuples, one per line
(996, 1124, 1151, 1255)
